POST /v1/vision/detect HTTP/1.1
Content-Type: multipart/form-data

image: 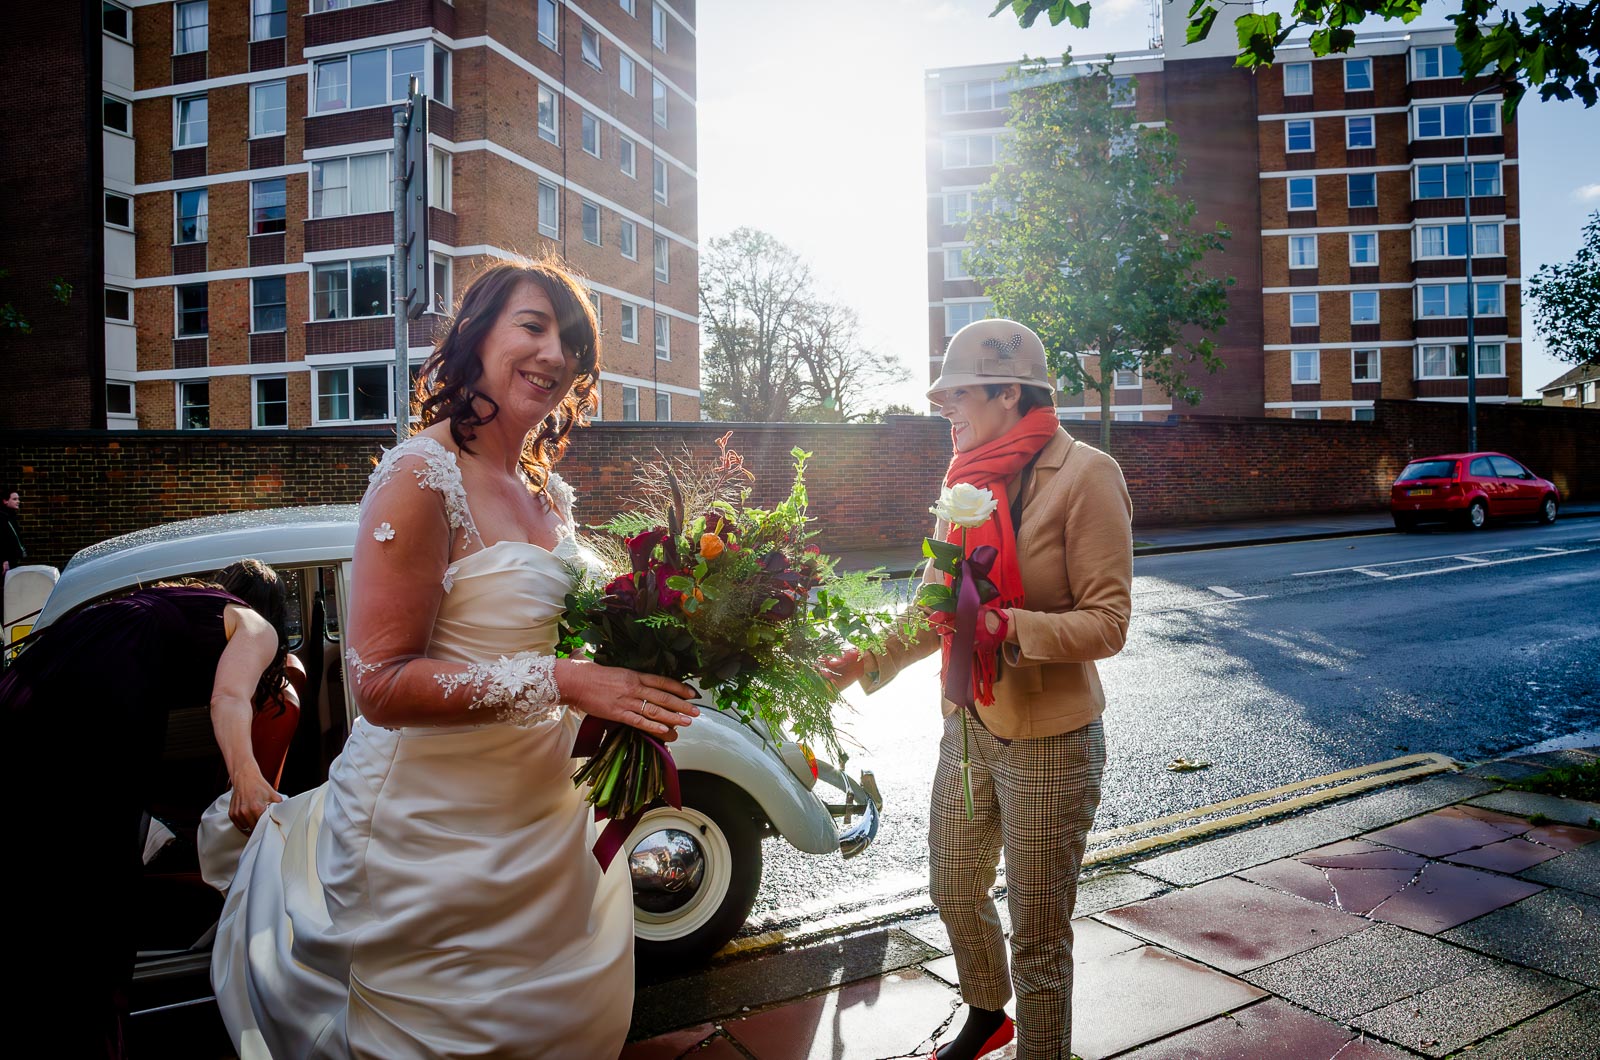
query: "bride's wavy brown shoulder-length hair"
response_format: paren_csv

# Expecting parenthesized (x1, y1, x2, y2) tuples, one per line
(411, 255, 600, 492)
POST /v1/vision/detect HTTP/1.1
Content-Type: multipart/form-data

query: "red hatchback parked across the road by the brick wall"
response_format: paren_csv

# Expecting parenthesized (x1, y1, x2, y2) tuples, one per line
(1389, 453, 1562, 532)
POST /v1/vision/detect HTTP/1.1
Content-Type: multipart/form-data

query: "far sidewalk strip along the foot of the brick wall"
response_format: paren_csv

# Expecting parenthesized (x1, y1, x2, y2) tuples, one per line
(835, 501, 1600, 576)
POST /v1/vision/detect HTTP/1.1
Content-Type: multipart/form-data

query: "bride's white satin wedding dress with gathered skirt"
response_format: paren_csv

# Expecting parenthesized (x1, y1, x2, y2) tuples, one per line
(202, 441, 634, 1060)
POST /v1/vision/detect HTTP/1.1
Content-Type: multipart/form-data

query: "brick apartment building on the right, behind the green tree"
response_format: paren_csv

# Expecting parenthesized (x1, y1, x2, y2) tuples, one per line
(926, 3, 1522, 421)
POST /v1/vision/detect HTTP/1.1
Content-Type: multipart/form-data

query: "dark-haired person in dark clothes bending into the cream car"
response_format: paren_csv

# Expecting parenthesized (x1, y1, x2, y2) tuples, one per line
(0, 559, 288, 1057)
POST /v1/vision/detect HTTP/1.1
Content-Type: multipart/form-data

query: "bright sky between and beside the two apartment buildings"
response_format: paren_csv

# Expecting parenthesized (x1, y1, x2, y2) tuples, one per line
(698, 0, 1600, 408)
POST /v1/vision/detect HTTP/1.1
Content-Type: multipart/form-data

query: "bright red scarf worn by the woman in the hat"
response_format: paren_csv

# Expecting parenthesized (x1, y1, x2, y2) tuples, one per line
(944, 407, 1061, 703)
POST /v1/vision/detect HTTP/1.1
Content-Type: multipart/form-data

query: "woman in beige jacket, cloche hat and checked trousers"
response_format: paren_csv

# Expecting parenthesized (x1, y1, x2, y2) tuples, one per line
(827, 320, 1133, 1060)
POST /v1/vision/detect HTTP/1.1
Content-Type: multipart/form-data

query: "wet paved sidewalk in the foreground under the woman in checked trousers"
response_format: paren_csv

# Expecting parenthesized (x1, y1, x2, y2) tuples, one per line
(622, 749, 1600, 1060)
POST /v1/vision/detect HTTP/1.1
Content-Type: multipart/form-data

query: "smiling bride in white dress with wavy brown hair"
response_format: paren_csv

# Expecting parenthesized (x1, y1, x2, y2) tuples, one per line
(202, 261, 698, 1060)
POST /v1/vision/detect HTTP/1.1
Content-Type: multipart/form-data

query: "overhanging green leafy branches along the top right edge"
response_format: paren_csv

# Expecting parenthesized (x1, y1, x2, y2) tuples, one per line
(990, 0, 1600, 114)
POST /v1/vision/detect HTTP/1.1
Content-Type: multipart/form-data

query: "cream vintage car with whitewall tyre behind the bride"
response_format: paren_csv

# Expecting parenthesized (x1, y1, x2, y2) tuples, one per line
(21, 506, 882, 1006)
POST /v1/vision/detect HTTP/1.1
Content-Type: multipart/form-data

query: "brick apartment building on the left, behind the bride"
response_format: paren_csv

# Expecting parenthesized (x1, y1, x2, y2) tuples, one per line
(13, 0, 699, 429)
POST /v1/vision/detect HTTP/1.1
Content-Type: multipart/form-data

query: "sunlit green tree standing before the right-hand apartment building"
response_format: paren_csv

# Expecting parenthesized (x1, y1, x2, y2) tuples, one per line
(968, 54, 1234, 448)
